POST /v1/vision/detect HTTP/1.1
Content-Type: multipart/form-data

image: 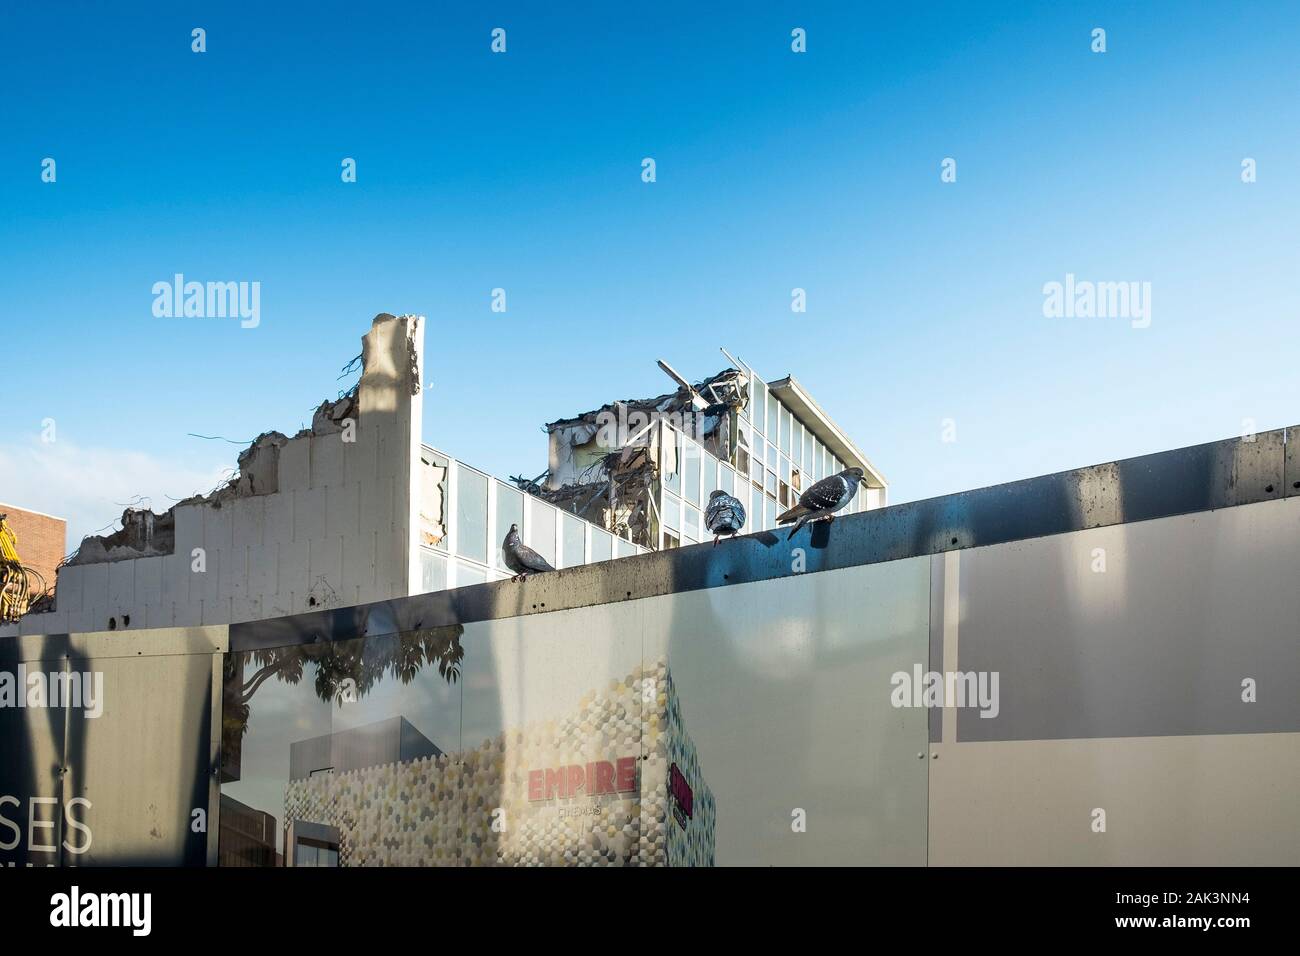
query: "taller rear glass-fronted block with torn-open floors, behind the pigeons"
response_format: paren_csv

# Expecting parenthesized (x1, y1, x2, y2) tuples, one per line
(512, 351, 888, 550)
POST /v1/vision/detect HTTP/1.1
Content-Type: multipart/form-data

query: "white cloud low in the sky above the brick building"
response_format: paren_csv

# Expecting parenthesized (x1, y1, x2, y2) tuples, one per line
(0, 438, 228, 551)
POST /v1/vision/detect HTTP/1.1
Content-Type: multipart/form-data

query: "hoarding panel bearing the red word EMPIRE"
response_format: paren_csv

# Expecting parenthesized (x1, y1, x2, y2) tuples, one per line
(463, 602, 650, 866)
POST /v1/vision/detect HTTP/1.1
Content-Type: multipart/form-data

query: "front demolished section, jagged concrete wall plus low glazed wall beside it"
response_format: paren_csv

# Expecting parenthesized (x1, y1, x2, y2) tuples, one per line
(0, 313, 645, 636)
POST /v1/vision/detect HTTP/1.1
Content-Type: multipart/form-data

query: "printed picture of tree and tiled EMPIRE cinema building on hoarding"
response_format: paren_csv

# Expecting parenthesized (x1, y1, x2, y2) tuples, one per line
(220, 628, 714, 866)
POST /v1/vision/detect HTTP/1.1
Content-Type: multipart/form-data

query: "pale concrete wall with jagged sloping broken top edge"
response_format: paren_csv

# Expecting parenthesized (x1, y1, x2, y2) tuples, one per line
(10, 313, 424, 633)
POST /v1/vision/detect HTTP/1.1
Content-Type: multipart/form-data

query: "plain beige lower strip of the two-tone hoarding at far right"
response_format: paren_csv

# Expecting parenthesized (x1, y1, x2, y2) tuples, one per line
(930, 734, 1300, 868)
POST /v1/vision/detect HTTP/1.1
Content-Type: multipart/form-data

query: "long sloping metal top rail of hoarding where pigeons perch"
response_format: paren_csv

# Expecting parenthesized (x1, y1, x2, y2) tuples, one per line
(230, 431, 1284, 650)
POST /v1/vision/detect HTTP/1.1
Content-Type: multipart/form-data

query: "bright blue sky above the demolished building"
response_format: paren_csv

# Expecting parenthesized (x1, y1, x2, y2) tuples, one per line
(0, 3, 1300, 548)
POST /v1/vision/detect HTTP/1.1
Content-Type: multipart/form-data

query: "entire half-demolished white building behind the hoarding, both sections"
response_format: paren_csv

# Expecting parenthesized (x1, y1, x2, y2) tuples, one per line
(0, 313, 887, 636)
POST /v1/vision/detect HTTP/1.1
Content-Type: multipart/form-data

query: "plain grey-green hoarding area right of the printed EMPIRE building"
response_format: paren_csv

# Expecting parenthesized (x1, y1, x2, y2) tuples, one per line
(637, 558, 930, 866)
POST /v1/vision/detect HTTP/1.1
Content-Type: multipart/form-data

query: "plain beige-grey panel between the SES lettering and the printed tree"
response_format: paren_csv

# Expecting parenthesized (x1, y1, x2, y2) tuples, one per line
(64, 654, 216, 866)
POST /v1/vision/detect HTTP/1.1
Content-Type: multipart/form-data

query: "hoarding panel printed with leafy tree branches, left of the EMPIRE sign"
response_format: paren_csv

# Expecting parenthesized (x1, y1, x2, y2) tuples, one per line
(220, 627, 463, 866)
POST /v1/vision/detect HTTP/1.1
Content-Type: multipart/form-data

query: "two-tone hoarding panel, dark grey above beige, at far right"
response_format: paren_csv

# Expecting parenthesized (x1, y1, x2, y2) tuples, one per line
(930, 498, 1300, 866)
